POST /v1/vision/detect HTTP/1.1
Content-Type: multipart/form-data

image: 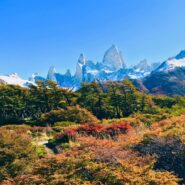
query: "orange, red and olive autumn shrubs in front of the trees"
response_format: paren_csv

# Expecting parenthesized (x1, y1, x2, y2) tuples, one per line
(0, 115, 185, 185)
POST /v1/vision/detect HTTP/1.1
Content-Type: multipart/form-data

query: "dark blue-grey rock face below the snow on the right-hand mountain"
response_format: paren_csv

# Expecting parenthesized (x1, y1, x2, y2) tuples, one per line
(143, 68, 185, 96)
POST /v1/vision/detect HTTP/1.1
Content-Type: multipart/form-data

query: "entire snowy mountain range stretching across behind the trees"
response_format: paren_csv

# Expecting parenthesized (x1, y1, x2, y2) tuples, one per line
(0, 45, 185, 95)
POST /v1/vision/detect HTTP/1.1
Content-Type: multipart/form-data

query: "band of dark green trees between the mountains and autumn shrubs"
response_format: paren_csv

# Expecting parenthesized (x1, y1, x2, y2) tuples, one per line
(0, 79, 182, 123)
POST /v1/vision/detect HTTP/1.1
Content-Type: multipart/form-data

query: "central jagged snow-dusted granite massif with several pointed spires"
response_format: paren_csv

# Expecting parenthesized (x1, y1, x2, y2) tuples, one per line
(34, 45, 153, 89)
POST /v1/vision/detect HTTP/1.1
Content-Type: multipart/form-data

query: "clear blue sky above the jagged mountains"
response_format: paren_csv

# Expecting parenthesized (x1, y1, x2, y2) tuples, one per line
(0, 0, 185, 78)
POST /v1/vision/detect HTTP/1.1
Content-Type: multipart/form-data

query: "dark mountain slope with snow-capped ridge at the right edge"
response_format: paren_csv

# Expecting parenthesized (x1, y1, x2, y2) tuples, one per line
(143, 51, 185, 95)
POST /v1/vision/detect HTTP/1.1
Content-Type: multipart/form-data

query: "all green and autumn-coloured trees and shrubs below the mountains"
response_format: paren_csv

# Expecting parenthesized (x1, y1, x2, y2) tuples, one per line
(0, 79, 185, 185)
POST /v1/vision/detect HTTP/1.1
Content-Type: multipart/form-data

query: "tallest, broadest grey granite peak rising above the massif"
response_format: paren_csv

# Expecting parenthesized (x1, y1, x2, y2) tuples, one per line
(103, 45, 126, 71)
